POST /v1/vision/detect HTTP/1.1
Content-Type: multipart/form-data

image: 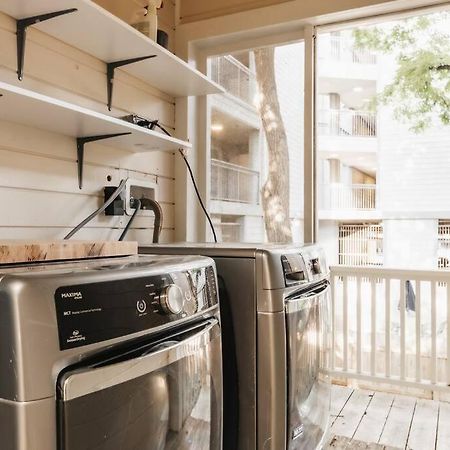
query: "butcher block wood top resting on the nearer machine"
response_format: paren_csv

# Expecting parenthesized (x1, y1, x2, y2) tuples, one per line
(0, 240, 138, 264)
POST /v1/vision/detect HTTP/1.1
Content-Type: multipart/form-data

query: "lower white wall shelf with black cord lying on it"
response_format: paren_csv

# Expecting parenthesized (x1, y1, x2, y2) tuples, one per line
(0, 82, 191, 152)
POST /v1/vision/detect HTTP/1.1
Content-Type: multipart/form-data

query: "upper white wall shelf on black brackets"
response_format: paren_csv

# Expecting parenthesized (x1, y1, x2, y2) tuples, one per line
(0, 0, 223, 97)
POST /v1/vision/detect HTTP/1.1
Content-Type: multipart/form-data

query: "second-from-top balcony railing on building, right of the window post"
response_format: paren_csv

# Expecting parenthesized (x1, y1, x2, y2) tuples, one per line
(317, 109, 377, 137)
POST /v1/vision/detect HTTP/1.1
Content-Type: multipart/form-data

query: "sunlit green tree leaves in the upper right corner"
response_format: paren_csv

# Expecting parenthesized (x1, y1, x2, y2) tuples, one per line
(353, 12, 450, 133)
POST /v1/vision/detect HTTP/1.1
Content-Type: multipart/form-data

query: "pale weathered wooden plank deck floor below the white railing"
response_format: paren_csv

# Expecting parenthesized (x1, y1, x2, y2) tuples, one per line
(326, 386, 450, 450)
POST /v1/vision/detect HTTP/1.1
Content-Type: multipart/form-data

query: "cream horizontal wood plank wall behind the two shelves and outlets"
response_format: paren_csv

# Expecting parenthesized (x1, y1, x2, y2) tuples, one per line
(0, 6, 178, 244)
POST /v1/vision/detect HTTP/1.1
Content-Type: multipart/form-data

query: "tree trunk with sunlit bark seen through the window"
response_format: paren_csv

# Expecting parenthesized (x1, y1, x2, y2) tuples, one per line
(255, 47, 292, 243)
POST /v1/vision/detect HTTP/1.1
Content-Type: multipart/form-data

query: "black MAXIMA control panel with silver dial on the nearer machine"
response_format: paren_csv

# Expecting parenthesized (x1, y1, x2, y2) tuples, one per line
(55, 266, 218, 350)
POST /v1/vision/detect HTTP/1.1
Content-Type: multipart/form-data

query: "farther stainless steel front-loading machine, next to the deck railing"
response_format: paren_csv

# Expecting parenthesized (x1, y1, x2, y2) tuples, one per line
(140, 244, 330, 450)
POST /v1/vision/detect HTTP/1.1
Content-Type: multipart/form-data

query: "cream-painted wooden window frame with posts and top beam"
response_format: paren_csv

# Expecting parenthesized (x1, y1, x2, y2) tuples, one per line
(175, 0, 449, 243)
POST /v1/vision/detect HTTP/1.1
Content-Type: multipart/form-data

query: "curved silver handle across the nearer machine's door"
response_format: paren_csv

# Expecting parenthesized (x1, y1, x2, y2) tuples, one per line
(62, 319, 220, 401)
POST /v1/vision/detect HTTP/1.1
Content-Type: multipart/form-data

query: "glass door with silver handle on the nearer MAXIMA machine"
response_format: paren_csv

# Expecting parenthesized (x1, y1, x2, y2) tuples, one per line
(58, 320, 222, 450)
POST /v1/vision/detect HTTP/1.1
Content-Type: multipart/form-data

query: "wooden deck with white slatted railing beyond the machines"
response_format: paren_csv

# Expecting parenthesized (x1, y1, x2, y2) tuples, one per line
(330, 266, 450, 450)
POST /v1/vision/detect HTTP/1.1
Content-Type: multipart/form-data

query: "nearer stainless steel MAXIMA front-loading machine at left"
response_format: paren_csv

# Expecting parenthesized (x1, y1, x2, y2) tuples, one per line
(0, 256, 222, 450)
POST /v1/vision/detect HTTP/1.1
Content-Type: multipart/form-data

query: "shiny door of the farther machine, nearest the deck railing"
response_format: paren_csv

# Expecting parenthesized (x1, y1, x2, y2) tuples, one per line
(285, 282, 330, 450)
